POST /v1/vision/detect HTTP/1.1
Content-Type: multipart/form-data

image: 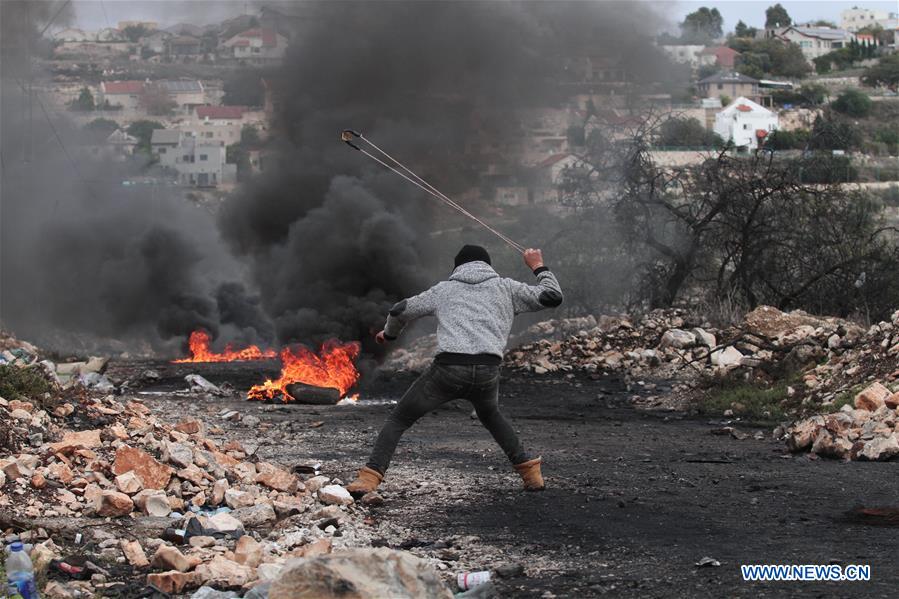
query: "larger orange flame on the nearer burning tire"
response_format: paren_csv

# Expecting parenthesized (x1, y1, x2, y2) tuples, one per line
(247, 339, 361, 401)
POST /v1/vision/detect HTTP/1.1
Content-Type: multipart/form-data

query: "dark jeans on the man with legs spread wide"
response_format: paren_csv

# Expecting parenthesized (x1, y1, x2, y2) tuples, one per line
(366, 364, 530, 474)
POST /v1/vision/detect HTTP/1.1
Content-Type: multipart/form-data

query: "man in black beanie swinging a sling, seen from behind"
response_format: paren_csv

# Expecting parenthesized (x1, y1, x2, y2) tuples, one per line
(347, 245, 562, 496)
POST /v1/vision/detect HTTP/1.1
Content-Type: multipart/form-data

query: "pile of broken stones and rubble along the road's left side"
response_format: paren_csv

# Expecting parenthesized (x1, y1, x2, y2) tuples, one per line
(0, 330, 450, 598)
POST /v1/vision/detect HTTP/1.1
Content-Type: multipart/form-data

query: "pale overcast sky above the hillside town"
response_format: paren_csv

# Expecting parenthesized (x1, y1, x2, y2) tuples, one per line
(67, 0, 899, 31)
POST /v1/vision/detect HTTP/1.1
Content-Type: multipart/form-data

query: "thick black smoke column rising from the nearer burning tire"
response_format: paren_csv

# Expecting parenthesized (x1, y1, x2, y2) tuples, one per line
(220, 2, 654, 352)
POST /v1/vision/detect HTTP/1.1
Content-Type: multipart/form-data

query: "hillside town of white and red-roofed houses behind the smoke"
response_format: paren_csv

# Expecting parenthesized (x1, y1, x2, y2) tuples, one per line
(17, 5, 899, 212)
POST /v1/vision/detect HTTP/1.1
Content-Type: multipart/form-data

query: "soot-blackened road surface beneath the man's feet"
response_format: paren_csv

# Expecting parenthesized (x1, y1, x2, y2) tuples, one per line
(139, 366, 899, 597)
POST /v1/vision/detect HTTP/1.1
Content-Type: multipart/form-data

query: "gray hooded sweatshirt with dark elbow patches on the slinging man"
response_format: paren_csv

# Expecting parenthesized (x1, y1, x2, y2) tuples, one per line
(384, 261, 562, 363)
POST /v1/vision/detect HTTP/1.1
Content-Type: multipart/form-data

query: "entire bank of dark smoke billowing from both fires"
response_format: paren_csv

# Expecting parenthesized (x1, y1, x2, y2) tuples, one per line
(0, 2, 659, 349)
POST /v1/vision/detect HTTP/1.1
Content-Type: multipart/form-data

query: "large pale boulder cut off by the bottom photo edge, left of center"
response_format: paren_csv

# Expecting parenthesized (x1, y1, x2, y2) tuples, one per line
(269, 547, 453, 599)
